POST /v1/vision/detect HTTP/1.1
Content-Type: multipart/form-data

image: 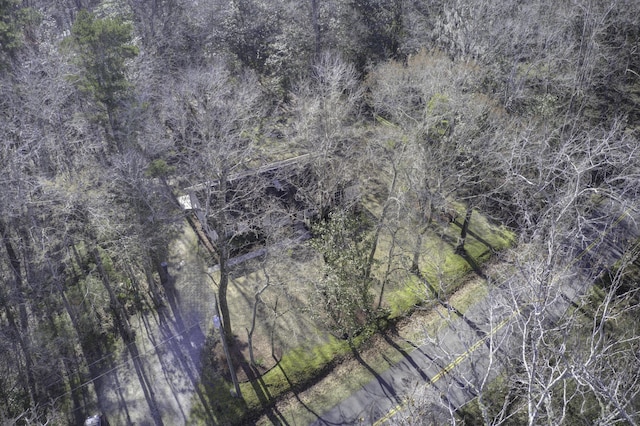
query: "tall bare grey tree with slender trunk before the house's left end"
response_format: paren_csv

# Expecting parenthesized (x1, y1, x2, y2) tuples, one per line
(165, 65, 264, 339)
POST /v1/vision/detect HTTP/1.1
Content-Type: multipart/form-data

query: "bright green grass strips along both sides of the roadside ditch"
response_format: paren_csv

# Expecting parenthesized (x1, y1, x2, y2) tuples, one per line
(192, 208, 514, 424)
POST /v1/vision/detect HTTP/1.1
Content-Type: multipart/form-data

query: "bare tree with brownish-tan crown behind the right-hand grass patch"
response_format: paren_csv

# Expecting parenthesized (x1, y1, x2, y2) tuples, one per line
(369, 52, 508, 254)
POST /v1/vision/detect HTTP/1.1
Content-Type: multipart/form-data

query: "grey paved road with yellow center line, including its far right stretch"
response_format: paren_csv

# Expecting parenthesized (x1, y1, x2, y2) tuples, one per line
(312, 205, 640, 426)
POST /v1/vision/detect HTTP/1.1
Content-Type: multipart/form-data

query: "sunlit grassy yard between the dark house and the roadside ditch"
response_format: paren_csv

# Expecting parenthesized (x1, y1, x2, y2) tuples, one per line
(184, 201, 511, 423)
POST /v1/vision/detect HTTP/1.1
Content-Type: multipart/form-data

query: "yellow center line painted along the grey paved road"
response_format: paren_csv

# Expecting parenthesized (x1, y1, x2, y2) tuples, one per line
(373, 205, 634, 426)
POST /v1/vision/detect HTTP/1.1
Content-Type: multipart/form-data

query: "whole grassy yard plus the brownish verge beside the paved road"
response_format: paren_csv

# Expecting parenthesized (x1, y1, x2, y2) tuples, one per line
(185, 177, 514, 424)
